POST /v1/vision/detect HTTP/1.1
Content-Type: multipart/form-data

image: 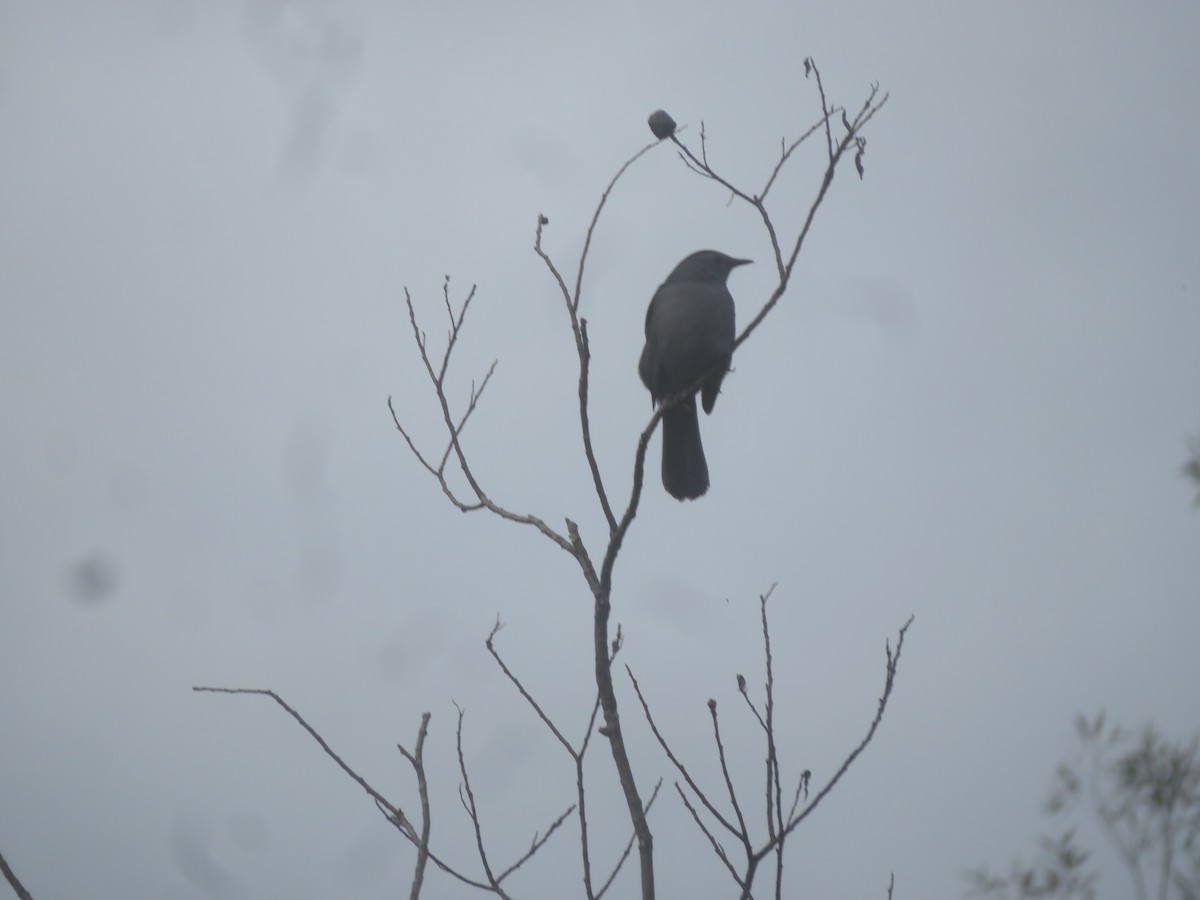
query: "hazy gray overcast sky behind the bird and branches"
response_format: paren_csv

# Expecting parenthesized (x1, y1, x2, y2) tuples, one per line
(0, 0, 1200, 900)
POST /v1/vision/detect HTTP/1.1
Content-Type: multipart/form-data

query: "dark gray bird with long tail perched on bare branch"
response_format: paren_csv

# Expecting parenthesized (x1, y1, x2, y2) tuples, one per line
(637, 250, 750, 500)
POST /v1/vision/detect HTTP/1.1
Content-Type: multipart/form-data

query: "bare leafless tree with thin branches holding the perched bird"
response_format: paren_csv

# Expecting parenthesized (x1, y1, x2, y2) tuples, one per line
(196, 59, 911, 900)
